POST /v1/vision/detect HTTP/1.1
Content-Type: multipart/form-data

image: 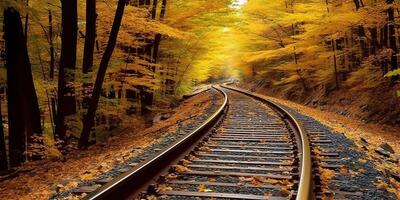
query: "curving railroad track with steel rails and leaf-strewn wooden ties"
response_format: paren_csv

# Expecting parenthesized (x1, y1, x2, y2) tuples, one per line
(86, 86, 313, 200)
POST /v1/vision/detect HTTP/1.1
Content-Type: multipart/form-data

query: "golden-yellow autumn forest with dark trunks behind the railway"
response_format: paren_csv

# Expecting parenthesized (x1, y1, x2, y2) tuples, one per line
(0, 0, 400, 198)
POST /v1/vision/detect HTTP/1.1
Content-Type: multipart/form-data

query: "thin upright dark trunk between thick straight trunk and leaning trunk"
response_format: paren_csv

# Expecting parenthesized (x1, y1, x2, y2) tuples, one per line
(82, 0, 97, 108)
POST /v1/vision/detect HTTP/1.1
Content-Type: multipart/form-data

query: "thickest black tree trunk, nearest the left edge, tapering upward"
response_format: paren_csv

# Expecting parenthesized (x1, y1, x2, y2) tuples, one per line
(3, 8, 42, 167)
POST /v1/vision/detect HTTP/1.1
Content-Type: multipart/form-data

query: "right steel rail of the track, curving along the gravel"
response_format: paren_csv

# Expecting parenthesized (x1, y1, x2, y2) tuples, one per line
(221, 83, 315, 200)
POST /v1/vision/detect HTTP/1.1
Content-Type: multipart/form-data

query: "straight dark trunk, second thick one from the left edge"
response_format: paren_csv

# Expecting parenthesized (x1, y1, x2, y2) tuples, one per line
(56, 0, 78, 140)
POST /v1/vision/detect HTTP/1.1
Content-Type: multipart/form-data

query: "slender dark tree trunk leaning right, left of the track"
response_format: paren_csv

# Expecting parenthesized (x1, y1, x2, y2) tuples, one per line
(79, 0, 126, 148)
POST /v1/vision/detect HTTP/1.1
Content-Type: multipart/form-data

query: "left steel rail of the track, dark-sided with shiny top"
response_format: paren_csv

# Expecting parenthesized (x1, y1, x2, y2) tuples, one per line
(84, 86, 228, 200)
